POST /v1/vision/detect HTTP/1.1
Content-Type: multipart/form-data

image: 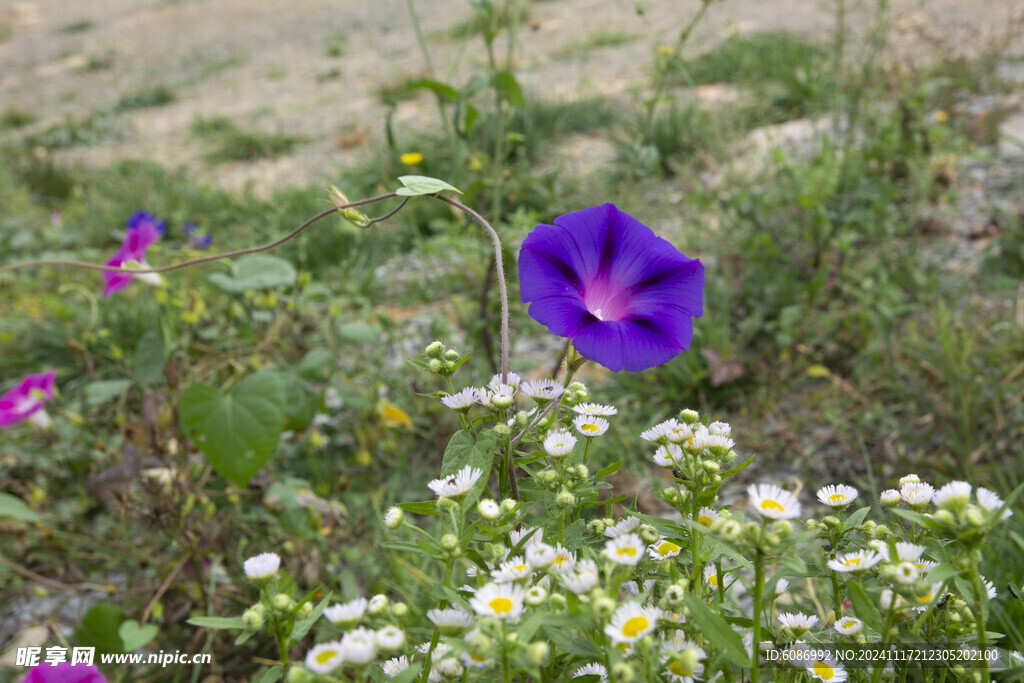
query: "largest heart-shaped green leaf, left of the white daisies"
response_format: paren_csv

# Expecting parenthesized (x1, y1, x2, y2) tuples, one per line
(178, 372, 287, 486)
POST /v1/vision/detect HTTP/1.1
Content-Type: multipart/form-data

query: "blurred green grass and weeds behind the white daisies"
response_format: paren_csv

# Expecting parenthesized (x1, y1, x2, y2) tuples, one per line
(0, 3, 1024, 680)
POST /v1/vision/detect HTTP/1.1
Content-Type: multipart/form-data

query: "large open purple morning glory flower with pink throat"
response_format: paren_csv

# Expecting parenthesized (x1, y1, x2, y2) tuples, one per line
(519, 204, 705, 372)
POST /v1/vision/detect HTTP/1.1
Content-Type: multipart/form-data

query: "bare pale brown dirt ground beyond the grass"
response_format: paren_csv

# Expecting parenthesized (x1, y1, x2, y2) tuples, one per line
(0, 0, 1024, 189)
